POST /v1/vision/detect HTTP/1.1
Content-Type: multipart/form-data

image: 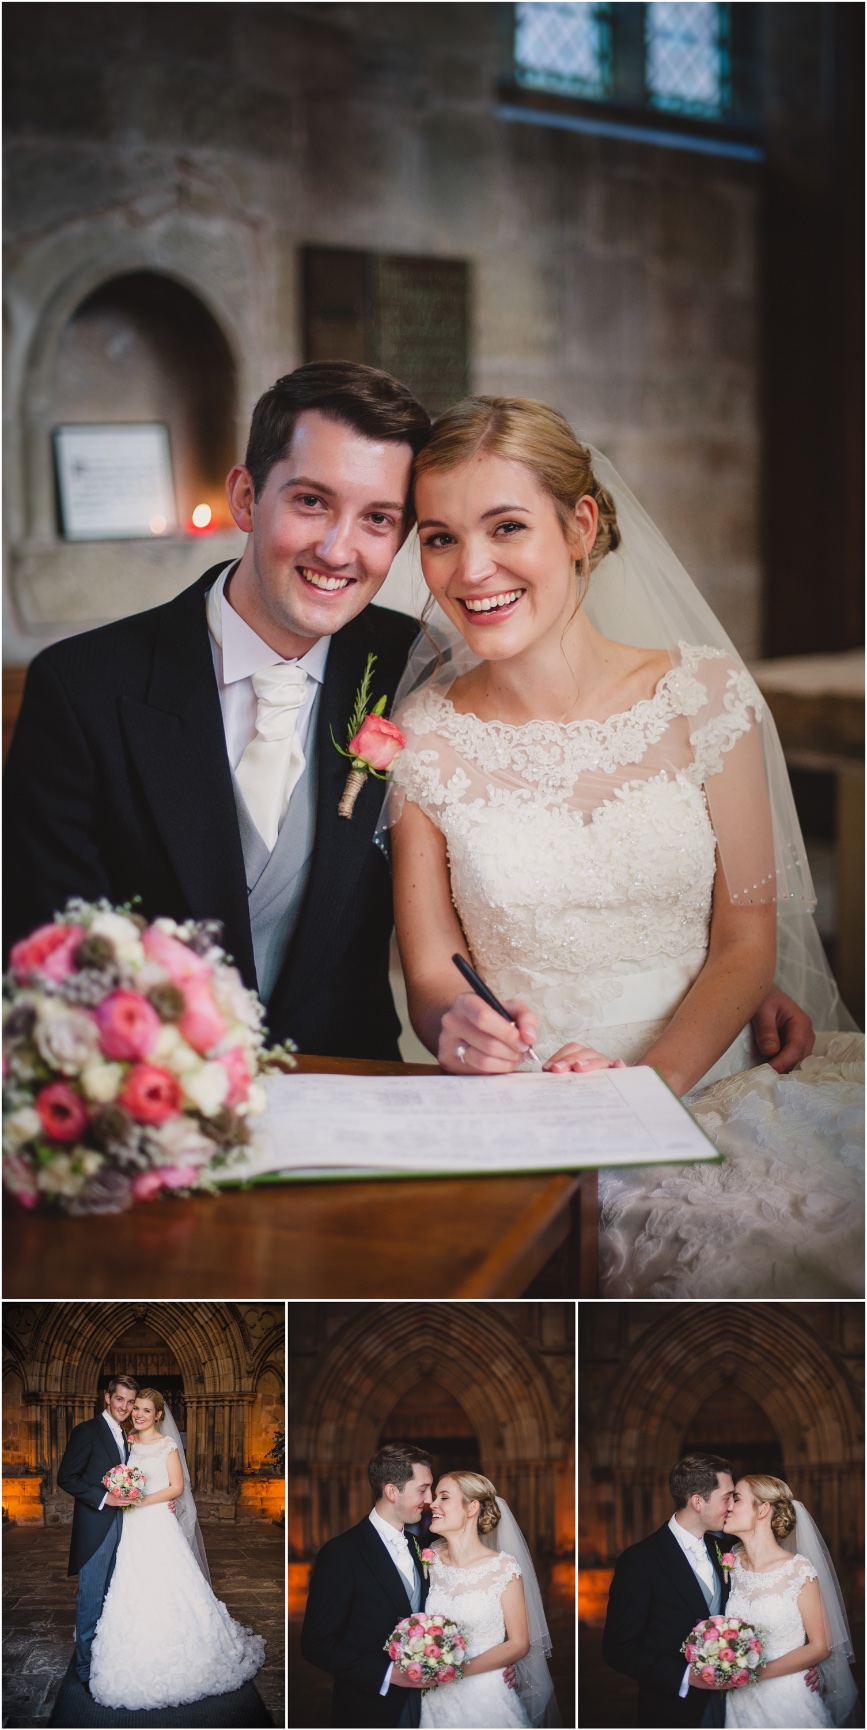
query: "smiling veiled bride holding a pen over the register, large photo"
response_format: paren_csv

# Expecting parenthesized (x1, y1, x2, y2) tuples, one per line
(384, 398, 864, 1298)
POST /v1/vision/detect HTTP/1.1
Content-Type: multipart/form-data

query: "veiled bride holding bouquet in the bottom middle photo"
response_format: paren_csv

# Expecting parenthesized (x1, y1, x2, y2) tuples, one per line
(421, 1472, 559, 1730)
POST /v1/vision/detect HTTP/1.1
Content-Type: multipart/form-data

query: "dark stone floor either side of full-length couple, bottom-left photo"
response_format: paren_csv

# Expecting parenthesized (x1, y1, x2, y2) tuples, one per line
(3, 1521, 286, 1730)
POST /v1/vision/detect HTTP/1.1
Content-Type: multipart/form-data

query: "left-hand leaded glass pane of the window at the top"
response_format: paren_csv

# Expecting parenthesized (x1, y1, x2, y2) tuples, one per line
(514, 0, 611, 97)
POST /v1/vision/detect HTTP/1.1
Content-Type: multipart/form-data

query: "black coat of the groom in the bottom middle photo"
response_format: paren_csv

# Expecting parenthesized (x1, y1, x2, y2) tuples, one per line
(301, 1519, 427, 1730)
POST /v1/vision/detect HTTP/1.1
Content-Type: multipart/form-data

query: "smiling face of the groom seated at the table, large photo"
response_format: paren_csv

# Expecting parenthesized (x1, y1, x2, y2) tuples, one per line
(227, 410, 412, 659)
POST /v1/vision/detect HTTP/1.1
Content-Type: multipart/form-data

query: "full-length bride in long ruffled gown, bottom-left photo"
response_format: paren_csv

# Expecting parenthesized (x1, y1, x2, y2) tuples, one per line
(90, 1387, 265, 1711)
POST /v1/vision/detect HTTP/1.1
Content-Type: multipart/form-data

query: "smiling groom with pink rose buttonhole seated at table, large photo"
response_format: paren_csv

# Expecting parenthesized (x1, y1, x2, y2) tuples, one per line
(5, 362, 812, 1071)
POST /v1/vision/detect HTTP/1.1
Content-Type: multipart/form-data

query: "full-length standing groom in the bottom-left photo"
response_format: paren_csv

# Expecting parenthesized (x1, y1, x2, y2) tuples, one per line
(57, 1375, 138, 1692)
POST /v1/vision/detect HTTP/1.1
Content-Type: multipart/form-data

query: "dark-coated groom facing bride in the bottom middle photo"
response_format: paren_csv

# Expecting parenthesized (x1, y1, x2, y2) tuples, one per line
(301, 1443, 439, 1730)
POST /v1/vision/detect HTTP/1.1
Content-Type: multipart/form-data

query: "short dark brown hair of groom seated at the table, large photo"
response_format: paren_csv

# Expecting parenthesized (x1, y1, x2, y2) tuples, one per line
(244, 360, 431, 498)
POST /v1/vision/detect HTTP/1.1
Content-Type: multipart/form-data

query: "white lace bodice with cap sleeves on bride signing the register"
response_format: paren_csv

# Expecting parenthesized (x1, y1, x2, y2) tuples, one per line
(395, 645, 768, 1059)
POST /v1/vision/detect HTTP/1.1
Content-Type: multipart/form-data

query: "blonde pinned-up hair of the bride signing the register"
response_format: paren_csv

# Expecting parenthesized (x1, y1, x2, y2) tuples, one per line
(412, 396, 620, 599)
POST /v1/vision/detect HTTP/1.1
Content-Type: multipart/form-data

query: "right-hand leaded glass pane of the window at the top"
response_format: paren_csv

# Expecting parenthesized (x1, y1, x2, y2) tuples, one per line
(644, 0, 730, 116)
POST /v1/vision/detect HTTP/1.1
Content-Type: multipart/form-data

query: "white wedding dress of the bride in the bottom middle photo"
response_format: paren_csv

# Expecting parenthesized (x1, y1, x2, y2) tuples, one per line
(421, 1550, 530, 1730)
